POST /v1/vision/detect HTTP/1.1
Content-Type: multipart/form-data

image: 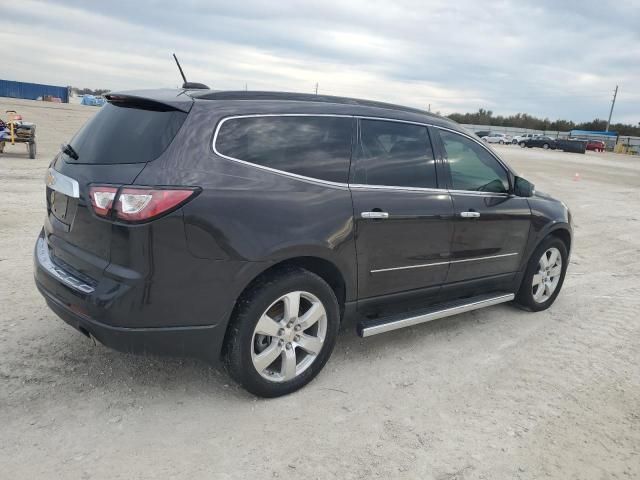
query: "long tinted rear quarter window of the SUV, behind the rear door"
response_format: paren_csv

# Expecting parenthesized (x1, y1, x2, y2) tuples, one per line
(215, 116, 353, 183)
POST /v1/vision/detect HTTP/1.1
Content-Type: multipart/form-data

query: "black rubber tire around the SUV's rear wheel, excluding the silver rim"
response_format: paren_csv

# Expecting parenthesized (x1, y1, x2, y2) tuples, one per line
(225, 267, 340, 397)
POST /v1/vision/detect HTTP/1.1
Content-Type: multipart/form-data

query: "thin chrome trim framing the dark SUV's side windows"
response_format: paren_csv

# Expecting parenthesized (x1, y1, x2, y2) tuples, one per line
(211, 113, 513, 197)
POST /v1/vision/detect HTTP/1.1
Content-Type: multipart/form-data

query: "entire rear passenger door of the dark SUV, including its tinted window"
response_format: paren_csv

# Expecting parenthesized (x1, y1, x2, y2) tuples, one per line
(351, 119, 453, 303)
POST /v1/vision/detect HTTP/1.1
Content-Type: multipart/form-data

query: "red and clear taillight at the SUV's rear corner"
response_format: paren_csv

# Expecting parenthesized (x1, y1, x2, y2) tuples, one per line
(89, 186, 199, 223)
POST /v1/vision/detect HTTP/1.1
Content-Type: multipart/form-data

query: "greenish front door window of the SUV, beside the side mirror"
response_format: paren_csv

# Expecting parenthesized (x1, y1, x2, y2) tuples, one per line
(440, 130, 509, 193)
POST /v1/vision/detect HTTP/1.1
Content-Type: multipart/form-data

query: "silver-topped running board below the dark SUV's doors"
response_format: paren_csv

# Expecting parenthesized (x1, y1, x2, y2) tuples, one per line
(358, 293, 515, 337)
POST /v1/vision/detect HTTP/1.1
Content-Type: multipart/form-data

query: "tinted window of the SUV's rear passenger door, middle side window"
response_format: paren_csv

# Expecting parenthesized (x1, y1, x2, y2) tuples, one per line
(353, 120, 437, 188)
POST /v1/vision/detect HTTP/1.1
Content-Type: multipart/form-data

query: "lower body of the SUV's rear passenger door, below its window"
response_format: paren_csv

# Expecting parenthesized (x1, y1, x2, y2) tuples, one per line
(351, 186, 453, 298)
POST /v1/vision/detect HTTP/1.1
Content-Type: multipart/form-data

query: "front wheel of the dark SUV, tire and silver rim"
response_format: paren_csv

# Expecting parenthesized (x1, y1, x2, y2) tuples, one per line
(516, 236, 569, 312)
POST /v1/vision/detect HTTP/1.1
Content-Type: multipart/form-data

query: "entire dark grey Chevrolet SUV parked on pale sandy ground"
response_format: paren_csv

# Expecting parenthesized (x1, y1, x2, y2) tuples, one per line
(34, 90, 572, 397)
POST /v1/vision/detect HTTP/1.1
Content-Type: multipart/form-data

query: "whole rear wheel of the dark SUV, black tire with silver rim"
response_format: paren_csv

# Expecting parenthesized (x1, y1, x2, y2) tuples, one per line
(226, 268, 340, 397)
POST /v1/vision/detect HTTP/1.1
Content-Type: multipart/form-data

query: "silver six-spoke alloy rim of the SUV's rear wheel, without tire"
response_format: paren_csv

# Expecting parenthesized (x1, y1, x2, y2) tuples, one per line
(251, 291, 327, 382)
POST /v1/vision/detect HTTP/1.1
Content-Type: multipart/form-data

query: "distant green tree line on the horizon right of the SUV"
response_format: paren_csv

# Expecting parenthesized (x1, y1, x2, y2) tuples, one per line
(448, 108, 640, 137)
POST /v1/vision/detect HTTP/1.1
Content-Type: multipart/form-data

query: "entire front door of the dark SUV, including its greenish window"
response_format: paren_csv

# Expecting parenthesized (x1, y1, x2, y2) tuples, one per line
(437, 130, 531, 289)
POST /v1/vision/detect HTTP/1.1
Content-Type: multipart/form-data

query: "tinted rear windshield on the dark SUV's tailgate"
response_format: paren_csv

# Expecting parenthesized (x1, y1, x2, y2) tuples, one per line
(68, 103, 187, 164)
